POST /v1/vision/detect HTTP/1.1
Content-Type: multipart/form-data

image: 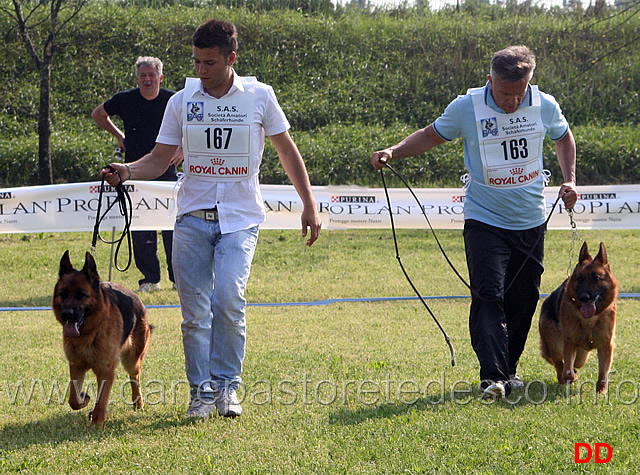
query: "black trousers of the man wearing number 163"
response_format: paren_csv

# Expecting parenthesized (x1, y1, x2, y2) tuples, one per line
(464, 220, 546, 390)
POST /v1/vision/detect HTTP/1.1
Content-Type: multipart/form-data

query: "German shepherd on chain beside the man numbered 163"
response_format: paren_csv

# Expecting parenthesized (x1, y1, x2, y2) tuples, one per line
(539, 242, 618, 393)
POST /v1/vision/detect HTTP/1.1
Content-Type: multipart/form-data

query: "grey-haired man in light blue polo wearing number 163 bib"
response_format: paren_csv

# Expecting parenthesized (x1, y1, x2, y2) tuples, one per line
(371, 46, 577, 399)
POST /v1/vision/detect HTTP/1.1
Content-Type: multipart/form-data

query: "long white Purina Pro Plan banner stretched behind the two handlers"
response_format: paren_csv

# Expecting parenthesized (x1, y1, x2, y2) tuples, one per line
(0, 181, 640, 233)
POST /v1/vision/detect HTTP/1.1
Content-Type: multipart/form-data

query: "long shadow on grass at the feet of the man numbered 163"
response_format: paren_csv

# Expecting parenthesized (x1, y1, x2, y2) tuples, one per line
(329, 381, 589, 426)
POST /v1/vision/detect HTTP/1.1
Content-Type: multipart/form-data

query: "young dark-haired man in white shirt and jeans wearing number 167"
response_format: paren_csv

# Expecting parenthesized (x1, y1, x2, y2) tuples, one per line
(103, 19, 322, 418)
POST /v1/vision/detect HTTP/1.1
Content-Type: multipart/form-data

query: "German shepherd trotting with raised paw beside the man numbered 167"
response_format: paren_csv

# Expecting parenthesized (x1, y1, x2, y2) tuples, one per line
(53, 251, 151, 428)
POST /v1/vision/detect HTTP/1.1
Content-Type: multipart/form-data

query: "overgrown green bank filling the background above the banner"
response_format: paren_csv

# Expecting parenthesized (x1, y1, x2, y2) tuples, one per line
(0, 0, 640, 185)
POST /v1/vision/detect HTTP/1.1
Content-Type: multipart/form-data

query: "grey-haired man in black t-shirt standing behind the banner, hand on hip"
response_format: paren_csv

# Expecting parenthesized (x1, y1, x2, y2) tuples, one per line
(91, 56, 182, 292)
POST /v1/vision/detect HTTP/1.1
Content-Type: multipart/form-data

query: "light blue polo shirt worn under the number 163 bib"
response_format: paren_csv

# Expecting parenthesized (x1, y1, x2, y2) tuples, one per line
(433, 82, 569, 230)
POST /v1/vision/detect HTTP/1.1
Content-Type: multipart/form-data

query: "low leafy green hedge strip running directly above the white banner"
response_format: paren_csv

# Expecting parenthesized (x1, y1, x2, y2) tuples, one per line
(0, 120, 640, 187)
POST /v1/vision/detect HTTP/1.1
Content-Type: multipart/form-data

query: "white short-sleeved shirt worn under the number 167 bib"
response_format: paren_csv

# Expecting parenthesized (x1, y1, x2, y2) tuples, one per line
(156, 71, 290, 234)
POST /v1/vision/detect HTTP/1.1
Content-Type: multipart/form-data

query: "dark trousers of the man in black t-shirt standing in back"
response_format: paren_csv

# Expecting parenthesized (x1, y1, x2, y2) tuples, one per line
(131, 231, 174, 284)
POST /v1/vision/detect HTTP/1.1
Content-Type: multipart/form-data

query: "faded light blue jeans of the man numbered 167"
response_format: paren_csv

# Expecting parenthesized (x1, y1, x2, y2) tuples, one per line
(173, 214, 258, 399)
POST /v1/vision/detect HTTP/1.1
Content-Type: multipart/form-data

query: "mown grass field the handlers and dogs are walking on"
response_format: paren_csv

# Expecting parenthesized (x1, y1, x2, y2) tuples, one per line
(0, 230, 640, 473)
